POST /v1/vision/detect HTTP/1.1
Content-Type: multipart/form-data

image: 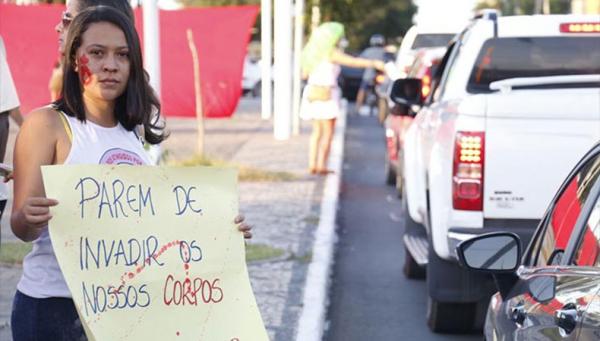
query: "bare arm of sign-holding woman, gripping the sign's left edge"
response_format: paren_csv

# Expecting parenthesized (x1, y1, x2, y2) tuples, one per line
(10, 108, 64, 241)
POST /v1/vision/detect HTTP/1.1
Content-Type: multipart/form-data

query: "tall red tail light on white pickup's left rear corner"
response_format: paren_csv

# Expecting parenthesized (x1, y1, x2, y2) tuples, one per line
(452, 131, 485, 211)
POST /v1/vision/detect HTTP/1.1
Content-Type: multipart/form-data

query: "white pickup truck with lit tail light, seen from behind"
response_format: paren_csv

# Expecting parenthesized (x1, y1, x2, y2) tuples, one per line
(392, 15, 600, 331)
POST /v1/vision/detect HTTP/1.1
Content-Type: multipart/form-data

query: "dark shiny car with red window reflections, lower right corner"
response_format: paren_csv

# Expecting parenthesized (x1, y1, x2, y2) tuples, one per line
(457, 144, 600, 340)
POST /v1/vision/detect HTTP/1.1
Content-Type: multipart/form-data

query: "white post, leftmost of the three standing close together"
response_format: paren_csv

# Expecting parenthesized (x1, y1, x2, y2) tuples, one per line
(260, 0, 273, 120)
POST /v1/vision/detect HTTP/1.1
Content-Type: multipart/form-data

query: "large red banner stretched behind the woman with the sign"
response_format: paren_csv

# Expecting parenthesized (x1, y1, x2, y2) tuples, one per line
(0, 4, 258, 117)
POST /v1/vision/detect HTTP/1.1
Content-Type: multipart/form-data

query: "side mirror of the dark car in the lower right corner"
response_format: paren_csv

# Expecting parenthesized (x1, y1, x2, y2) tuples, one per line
(456, 232, 521, 274)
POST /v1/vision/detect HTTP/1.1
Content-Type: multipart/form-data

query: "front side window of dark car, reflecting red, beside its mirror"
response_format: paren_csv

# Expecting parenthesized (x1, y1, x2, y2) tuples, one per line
(533, 155, 600, 266)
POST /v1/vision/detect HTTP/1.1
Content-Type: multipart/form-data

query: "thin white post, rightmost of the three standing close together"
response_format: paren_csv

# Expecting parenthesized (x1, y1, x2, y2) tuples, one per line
(292, 0, 304, 135)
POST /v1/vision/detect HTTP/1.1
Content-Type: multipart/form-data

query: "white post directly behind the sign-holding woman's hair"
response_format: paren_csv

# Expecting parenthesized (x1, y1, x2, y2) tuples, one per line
(142, 0, 162, 164)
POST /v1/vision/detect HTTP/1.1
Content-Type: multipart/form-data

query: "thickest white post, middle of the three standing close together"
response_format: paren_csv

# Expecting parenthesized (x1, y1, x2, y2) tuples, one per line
(273, 0, 292, 140)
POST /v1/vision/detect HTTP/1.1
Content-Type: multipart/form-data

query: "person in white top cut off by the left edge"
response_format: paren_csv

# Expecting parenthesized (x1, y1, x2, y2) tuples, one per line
(0, 36, 23, 244)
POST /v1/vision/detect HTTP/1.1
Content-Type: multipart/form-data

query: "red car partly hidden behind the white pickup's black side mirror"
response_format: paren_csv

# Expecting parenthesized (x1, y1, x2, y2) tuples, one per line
(384, 47, 446, 191)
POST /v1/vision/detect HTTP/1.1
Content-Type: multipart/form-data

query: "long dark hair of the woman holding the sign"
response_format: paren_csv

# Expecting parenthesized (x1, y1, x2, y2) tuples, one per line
(54, 6, 165, 144)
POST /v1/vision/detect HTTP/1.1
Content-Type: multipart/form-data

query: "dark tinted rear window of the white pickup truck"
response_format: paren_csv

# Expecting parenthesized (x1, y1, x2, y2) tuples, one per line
(467, 36, 600, 93)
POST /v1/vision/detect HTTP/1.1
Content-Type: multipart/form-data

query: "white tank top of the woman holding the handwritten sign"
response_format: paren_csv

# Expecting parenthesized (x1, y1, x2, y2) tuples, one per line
(17, 109, 150, 298)
